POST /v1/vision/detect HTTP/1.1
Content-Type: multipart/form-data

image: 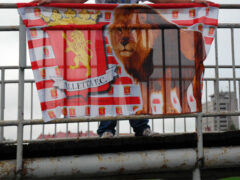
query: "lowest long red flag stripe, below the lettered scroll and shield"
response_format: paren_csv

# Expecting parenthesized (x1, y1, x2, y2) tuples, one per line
(41, 97, 141, 111)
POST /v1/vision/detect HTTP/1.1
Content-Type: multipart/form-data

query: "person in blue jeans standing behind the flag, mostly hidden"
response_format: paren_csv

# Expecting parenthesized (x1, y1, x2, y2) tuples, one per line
(33, 0, 206, 138)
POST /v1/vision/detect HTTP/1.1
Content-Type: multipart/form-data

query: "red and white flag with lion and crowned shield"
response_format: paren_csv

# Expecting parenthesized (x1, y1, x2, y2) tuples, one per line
(18, 3, 218, 121)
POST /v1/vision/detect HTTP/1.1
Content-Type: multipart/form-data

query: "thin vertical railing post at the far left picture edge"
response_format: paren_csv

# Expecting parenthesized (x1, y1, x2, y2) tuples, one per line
(0, 68, 5, 142)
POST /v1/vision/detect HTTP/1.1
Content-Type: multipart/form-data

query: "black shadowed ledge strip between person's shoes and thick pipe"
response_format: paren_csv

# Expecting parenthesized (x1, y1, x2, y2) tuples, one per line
(0, 131, 240, 161)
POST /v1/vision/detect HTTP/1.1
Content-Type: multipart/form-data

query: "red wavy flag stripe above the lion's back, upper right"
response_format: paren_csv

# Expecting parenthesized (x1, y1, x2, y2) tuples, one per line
(172, 16, 218, 26)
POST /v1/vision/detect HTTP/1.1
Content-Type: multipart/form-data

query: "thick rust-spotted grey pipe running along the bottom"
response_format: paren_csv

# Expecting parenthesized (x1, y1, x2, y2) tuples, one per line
(0, 146, 240, 178)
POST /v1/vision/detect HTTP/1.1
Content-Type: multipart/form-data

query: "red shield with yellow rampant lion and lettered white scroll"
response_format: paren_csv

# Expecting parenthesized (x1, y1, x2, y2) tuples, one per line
(47, 30, 109, 97)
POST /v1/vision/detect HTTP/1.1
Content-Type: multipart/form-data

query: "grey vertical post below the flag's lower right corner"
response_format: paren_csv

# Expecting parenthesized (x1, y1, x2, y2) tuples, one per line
(193, 113, 204, 180)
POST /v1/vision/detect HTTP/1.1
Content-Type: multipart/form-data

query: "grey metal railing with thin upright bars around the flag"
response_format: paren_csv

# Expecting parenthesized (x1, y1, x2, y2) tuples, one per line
(0, 3, 240, 179)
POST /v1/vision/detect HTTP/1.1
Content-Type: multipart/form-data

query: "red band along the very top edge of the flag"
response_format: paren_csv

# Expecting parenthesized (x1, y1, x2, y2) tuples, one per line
(17, 2, 220, 10)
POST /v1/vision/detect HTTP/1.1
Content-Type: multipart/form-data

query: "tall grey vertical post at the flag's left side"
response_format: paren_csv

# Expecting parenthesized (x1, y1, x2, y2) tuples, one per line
(16, 18, 26, 179)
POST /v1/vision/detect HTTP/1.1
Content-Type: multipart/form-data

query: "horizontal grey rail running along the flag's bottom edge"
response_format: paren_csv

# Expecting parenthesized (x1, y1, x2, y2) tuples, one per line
(0, 112, 240, 126)
